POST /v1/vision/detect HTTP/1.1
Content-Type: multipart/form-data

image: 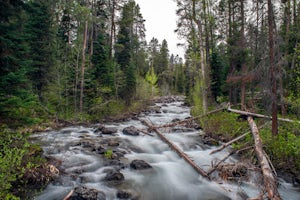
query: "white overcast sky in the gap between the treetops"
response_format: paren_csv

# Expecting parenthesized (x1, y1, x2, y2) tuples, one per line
(135, 0, 184, 58)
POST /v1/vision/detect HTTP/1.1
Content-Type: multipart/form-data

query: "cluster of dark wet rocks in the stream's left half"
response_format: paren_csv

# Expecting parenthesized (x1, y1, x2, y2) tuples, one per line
(69, 125, 152, 200)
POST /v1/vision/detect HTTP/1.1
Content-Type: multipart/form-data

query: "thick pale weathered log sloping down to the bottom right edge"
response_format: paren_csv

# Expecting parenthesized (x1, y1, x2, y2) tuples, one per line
(247, 116, 281, 200)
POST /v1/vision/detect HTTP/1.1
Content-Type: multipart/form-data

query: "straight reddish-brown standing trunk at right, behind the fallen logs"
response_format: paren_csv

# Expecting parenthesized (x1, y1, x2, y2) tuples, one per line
(268, 0, 278, 135)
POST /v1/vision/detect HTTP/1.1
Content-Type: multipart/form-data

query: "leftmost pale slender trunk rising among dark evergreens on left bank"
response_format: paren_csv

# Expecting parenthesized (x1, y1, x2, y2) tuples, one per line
(79, 21, 88, 113)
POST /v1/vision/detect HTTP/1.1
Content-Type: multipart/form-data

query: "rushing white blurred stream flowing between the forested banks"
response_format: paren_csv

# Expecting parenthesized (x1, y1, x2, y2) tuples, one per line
(32, 97, 300, 200)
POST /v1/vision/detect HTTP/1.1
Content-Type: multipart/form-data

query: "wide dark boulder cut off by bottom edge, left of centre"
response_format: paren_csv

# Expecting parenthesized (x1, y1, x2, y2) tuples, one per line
(69, 186, 106, 200)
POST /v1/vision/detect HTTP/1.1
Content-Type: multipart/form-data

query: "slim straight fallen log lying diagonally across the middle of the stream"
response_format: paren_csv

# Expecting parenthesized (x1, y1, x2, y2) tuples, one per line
(141, 120, 210, 180)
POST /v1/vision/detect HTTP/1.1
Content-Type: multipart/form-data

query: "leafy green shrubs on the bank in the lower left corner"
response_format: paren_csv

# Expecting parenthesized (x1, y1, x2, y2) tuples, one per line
(0, 127, 44, 199)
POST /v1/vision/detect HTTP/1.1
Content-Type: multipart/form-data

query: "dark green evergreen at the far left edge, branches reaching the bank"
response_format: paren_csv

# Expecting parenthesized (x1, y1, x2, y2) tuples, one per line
(0, 0, 36, 125)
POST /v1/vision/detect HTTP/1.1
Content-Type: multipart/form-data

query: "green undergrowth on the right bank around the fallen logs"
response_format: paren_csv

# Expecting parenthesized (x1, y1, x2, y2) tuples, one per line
(196, 111, 300, 178)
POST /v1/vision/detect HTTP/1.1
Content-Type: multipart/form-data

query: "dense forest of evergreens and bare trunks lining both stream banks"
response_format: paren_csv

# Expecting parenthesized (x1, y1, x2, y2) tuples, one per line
(0, 0, 300, 198)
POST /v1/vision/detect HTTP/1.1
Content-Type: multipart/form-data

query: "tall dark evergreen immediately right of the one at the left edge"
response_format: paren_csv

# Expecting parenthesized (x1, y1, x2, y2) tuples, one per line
(26, 0, 54, 101)
